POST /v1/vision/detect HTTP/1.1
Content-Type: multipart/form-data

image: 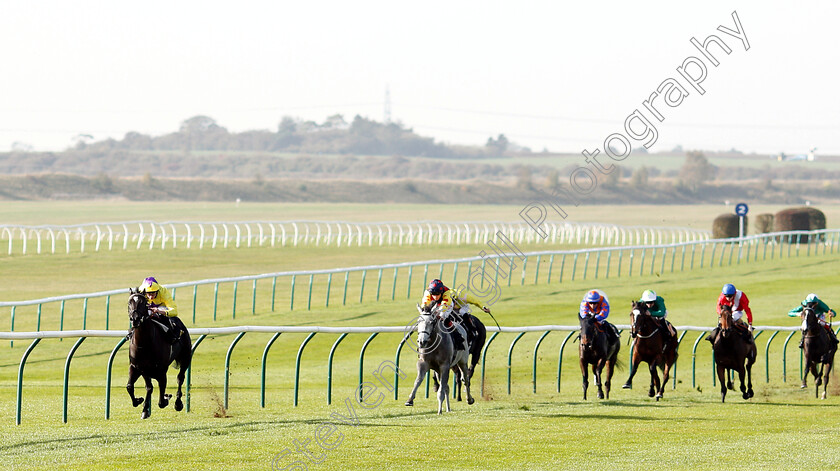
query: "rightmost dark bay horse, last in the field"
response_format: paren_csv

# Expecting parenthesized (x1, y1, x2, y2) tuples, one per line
(801, 307, 837, 399)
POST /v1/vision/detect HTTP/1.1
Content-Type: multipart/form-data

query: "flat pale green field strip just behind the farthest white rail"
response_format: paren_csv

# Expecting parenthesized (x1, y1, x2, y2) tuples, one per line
(0, 201, 840, 230)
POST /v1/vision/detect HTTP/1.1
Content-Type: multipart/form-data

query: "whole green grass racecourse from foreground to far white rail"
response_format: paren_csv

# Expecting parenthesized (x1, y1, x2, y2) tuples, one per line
(0, 202, 840, 470)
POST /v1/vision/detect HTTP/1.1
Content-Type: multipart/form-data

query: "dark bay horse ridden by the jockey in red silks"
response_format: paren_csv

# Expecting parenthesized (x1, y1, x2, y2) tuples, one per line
(712, 306, 757, 402)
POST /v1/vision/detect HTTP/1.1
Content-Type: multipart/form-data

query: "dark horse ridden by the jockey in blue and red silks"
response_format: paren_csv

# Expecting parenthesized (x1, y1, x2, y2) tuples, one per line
(580, 315, 621, 401)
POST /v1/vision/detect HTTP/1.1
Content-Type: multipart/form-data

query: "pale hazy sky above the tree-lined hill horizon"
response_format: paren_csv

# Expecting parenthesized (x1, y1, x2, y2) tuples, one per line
(0, 1, 840, 154)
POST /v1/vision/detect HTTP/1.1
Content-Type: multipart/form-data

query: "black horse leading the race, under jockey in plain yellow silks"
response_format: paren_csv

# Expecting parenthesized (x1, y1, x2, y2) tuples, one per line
(125, 289, 192, 419)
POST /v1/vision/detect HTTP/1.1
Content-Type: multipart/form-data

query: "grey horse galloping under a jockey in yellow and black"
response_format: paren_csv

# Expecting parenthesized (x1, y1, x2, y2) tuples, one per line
(405, 306, 475, 414)
